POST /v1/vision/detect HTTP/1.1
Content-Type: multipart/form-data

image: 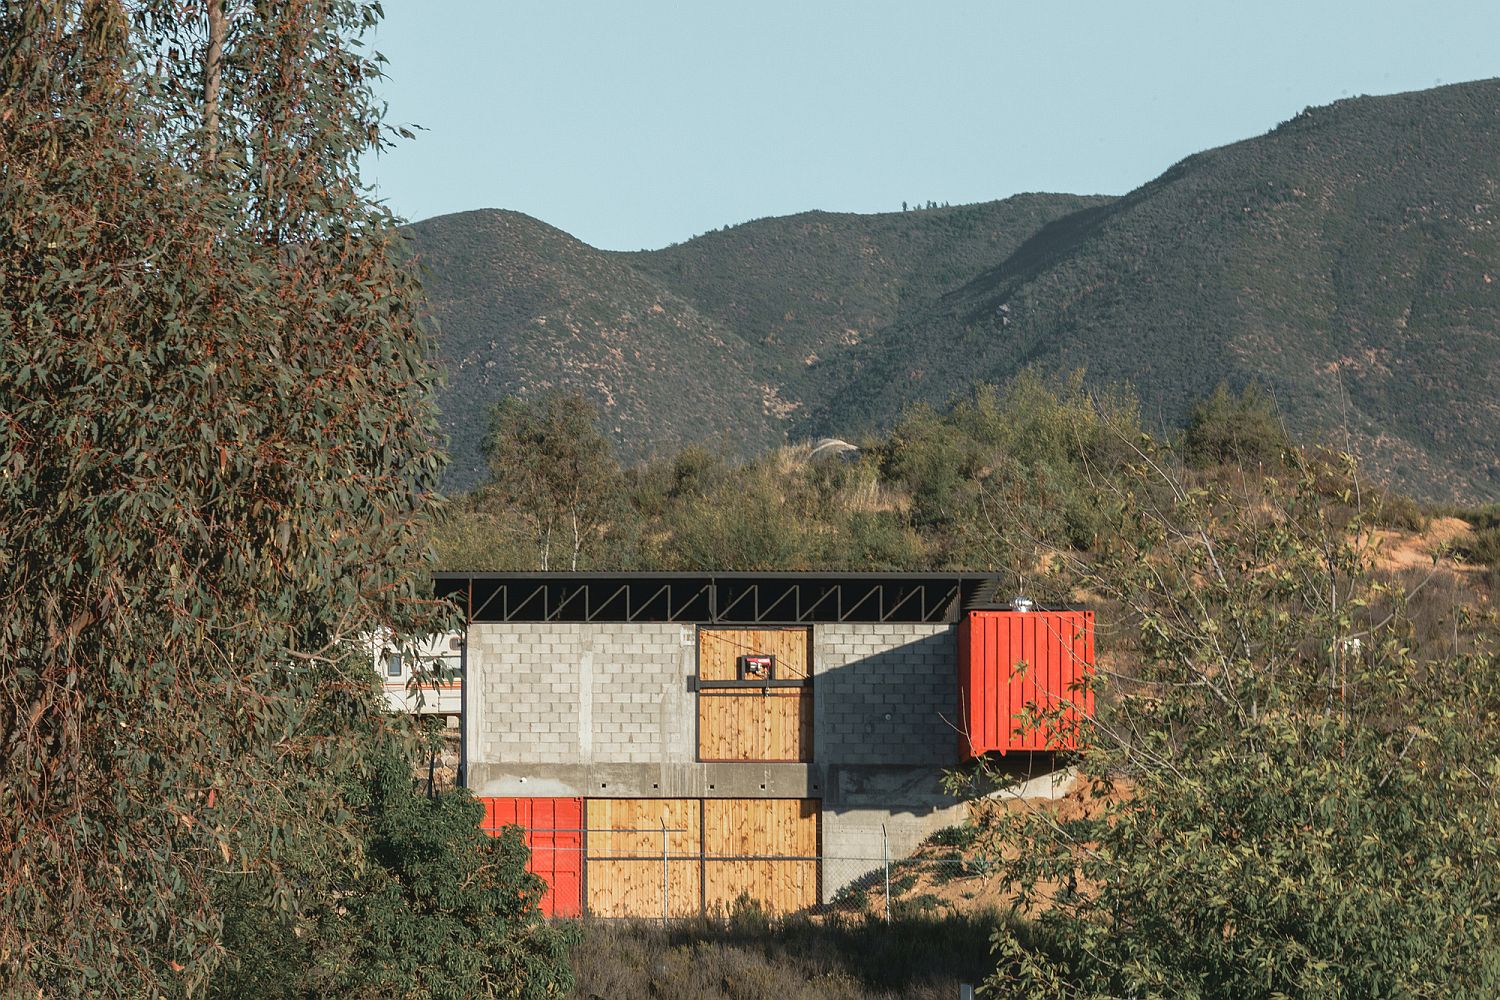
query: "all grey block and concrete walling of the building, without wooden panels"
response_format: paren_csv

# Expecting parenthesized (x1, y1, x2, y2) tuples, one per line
(467, 622, 963, 901)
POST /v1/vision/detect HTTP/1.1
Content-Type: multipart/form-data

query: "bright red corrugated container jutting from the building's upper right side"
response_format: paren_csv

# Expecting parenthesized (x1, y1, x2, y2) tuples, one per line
(959, 612, 1094, 757)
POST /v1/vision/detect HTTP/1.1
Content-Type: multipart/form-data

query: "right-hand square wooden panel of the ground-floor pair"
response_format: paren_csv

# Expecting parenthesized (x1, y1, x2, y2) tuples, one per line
(704, 799, 821, 913)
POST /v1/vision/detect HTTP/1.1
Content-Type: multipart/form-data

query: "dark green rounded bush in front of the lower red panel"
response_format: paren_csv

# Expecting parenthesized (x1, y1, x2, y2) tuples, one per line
(212, 738, 572, 1000)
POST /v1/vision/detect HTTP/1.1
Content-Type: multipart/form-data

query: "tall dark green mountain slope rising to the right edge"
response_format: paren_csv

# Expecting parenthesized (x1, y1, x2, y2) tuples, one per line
(801, 81, 1500, 499)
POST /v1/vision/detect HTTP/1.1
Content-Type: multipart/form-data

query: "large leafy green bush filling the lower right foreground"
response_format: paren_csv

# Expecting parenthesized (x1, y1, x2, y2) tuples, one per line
(986, 460, 1500, 999)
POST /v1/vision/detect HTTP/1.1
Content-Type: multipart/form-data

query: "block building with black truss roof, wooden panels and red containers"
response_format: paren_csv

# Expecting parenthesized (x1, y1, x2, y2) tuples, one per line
(423, 573, 1094, 916)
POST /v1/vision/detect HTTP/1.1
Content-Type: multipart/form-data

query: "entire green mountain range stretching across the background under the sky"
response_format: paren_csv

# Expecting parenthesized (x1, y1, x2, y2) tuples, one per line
(408, 81, 1500, 501)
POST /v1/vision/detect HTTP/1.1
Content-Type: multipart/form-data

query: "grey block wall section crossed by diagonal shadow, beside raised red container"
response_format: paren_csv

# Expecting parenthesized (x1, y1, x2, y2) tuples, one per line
(813, 625, 959, 765)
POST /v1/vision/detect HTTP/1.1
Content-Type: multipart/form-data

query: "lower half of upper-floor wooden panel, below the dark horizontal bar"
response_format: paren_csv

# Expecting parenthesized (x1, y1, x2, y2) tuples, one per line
(698, 688, 813, 760)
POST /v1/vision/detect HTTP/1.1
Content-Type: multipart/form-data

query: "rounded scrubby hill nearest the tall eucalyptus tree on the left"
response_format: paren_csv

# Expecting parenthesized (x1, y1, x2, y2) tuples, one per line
(408, 211, 782, 490)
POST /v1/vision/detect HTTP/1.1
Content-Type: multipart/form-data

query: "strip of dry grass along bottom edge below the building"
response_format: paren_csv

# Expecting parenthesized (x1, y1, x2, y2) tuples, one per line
(573, 907, 1001, 1000)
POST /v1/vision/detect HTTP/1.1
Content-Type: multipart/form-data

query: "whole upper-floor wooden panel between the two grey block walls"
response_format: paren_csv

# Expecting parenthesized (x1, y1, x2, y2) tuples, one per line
(698, 628, 813, 760)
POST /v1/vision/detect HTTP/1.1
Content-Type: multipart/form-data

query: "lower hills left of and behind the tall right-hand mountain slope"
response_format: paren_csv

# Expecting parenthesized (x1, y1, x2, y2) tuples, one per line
(407, 195, 1101, 489)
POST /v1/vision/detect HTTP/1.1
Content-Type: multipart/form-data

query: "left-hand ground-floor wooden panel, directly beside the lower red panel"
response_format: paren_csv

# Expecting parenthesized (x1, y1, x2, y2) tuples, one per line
(585, 799, 704, 918)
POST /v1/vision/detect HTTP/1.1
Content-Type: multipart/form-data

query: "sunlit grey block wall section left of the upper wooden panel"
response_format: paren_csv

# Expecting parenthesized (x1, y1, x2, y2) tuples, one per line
(468, 624, 695, 765)
